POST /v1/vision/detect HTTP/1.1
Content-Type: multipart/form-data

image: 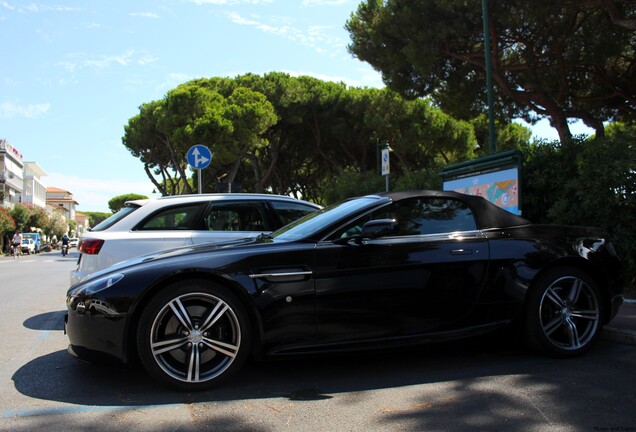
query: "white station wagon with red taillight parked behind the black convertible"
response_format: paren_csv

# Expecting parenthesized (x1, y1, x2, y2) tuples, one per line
(71, 194, 321, 284)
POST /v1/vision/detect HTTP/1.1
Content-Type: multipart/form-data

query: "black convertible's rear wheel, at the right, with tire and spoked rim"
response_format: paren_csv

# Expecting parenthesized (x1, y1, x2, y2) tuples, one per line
(525, 267, 603, 357)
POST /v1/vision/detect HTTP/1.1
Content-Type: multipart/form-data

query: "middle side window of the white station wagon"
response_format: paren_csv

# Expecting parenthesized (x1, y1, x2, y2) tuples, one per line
(204, 202, 271, 231)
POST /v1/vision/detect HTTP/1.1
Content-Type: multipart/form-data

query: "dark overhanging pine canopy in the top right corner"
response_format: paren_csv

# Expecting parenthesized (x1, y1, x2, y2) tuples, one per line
(346, 0, 636, 141)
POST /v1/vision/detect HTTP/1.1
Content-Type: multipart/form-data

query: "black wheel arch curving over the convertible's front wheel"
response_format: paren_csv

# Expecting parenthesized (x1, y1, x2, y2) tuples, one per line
(123, 269, 263, 363)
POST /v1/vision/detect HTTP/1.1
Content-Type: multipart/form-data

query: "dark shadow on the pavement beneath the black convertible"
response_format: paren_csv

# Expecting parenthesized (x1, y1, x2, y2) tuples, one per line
(12, 332, 559, 407)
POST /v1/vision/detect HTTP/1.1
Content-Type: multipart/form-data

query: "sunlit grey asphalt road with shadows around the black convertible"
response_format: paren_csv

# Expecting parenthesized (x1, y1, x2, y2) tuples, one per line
(0, 250, 636, 432)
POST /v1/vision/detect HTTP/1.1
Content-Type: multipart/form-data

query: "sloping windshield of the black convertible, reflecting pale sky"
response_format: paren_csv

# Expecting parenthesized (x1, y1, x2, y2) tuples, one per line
(272, 196, 386, 241)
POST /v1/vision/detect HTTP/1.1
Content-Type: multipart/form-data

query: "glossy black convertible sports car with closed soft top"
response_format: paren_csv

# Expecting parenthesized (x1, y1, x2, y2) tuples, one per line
(66, 191, 623, 390)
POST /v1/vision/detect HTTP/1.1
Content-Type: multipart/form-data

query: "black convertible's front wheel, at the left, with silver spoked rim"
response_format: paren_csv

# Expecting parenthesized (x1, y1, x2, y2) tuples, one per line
(137, 279, 251, 391)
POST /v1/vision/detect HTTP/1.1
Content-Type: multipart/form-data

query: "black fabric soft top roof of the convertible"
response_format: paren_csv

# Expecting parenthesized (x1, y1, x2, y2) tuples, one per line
(378, 190, 531, 229)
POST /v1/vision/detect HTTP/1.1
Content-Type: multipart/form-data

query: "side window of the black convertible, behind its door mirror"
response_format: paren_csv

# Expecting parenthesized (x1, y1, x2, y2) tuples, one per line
(332, 198, 477, 238)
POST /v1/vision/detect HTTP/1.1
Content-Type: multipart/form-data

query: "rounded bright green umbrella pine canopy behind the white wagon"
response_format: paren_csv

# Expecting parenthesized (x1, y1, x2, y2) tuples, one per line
(122, 72, 486, 202)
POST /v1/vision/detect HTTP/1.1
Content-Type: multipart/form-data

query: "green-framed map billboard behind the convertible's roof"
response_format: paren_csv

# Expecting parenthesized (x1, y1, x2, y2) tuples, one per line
(442, 151, 521, 215)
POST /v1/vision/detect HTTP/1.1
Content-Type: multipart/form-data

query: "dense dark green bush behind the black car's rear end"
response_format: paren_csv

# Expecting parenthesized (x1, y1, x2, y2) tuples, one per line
(520, 124, 636, 286)
